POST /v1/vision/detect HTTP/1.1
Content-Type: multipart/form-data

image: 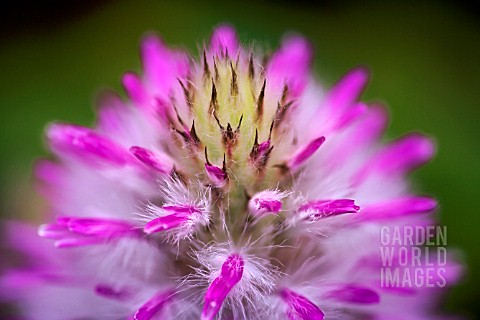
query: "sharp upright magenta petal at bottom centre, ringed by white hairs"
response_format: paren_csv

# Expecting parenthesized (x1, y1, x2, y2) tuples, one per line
(201, 254, 245, 320)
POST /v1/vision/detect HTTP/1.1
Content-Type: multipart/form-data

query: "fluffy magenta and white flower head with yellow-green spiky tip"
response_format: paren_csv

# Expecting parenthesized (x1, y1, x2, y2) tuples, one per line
(0, 26, 458, 320)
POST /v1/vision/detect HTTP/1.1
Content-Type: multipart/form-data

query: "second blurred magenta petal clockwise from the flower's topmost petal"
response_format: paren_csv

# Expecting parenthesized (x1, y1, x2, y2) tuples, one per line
(326, 67, 368, 112)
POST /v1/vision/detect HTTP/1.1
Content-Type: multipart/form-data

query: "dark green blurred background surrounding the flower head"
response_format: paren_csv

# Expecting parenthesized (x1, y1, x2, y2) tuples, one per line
(0, 0, 480, 318)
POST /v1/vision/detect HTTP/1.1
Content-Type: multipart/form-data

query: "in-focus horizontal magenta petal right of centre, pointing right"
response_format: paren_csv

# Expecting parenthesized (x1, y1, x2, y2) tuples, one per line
(297, 199, 360, 221)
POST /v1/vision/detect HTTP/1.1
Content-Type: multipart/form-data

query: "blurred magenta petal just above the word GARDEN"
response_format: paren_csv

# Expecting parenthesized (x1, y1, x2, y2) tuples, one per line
(357, 197, 437, 220)
